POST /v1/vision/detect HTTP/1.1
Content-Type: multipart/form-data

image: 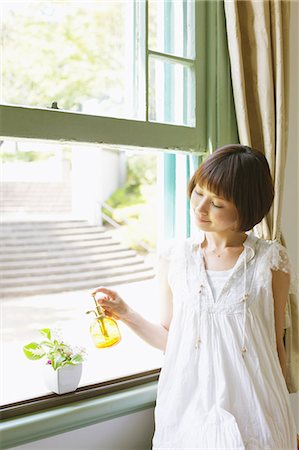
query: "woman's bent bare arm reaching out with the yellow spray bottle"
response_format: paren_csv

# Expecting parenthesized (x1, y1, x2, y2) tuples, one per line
(93, 258, 172, 351)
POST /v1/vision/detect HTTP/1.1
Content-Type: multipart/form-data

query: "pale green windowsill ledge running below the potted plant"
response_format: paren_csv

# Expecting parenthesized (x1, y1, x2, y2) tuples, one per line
(1, 374, 157, 449)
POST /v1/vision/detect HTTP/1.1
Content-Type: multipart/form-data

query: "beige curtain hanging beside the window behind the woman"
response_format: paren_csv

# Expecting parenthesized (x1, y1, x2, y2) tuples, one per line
(224, 0, 299, 392)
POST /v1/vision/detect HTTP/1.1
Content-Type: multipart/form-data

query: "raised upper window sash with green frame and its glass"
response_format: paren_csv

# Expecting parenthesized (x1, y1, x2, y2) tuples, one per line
(1, 0, 205, 151)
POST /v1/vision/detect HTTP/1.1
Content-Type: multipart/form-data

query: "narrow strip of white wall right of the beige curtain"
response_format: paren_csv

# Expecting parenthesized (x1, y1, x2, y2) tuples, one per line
(282, 1, 299, 433)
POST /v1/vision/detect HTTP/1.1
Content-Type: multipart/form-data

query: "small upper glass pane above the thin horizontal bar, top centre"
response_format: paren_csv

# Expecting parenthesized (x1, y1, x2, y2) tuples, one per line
(148, 0, 195, 59)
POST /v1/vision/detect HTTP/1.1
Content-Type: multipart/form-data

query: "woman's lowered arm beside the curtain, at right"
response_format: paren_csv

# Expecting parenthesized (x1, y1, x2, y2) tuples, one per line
(272, 270, 290, 377)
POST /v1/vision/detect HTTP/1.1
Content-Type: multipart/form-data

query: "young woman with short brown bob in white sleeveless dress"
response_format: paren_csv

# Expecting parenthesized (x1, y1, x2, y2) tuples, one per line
(95, 145, 297, 450)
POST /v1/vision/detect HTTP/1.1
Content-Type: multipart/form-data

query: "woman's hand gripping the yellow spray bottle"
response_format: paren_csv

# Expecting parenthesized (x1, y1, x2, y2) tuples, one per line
(92, 286, 130, 320)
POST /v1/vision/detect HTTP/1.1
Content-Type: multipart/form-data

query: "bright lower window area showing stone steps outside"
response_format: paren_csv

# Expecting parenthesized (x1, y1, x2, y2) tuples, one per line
(0, 141, 163, 404)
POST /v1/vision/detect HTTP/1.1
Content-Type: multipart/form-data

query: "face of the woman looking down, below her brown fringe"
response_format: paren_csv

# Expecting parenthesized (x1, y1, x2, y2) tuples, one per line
(191, 185, 238, 232)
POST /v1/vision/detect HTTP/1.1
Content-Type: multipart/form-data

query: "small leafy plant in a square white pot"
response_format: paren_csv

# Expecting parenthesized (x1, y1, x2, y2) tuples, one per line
(23, 328, 86, 394)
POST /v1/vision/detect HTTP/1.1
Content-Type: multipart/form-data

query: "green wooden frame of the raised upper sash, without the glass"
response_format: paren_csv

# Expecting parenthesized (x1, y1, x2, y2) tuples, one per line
(0, 0, 206, 153)
